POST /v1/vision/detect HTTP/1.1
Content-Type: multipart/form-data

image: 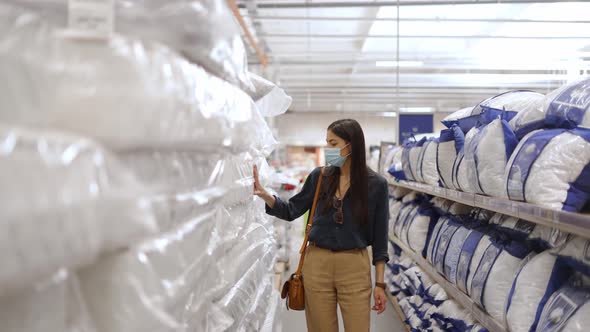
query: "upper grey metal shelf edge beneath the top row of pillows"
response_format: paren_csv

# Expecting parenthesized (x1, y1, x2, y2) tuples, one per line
(389, 180, 590, 238)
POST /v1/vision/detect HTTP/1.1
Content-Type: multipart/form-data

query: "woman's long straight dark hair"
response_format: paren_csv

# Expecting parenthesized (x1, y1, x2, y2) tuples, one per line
(322, 119, 369, 224)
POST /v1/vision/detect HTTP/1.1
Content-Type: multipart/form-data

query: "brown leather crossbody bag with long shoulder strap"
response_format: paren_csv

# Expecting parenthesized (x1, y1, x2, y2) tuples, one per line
(281, 168, 324, 310)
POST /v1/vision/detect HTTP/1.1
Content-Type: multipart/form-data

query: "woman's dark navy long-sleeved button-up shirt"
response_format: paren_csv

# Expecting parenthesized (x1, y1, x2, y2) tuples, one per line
(266, 168, 389, 264)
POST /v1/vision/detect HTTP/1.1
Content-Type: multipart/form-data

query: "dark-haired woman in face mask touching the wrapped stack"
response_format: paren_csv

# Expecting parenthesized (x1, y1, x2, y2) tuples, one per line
(254, 119, 389, 332)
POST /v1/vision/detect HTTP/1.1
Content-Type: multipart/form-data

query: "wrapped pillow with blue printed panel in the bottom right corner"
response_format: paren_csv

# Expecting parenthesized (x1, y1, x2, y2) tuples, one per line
(537, 282, 590, 332)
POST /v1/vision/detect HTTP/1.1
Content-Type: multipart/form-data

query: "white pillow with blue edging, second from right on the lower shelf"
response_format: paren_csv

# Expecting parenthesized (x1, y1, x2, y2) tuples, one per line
(506, 251, 573, 332)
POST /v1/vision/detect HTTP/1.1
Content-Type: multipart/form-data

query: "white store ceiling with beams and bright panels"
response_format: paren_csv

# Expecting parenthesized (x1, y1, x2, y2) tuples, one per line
(238, 0, 590, 113)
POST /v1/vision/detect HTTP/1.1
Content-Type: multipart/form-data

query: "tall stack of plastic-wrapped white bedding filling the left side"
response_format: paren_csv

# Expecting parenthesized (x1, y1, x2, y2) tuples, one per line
(0, 0, 290, 332)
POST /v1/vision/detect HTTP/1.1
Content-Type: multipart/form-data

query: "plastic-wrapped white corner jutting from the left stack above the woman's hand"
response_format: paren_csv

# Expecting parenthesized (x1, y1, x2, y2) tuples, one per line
(250, 73, 293, 117)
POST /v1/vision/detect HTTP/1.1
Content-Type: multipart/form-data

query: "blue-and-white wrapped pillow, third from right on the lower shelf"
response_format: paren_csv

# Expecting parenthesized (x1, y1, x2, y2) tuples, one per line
(469, 242, 530, 322)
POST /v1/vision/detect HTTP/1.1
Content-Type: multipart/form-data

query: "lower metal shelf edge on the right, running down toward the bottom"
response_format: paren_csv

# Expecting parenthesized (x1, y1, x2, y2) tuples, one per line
(389, 235, 507, 332)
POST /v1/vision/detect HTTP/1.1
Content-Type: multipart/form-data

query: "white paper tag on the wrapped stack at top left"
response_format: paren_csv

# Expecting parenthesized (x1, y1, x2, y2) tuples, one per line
(68, 0, 115, 39)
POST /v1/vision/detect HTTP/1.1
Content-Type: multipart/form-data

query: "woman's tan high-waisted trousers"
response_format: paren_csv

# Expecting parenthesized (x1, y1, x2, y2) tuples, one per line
(303, 245, 372, 332)
